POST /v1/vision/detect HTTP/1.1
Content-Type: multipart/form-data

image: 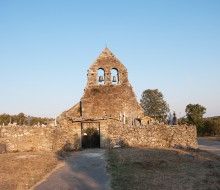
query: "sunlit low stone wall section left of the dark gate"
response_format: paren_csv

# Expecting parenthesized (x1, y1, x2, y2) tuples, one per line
(0, 123, 81, 153)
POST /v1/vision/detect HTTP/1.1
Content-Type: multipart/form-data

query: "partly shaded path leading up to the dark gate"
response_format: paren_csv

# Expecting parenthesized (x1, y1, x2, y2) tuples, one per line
(34, 149, 110, 190)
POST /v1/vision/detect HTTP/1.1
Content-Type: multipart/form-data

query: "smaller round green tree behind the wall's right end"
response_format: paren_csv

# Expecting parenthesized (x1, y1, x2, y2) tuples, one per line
(185, 104, 206, 128)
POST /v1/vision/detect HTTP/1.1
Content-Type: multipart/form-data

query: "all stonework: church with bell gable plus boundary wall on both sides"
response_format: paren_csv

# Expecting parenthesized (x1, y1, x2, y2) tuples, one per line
(0, 48, 198, 153)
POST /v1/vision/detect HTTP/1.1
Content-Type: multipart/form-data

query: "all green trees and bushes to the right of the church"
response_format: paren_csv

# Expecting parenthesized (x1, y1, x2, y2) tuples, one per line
(140, 89, 220, 136)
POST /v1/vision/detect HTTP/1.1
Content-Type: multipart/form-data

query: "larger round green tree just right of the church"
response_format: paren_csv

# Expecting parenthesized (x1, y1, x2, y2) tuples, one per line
(140, 89, 170, 121)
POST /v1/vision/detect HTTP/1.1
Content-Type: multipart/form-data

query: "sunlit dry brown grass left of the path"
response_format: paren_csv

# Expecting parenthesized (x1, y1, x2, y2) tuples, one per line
(0, 152, 59, 190)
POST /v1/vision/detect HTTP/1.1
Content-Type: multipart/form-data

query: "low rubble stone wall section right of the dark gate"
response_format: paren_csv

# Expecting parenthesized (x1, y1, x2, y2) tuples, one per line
(107, 125, 198, 149)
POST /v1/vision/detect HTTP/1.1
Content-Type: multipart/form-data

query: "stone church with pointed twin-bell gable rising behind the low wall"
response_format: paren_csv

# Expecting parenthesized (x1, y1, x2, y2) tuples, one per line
(58, 48, 144, 147)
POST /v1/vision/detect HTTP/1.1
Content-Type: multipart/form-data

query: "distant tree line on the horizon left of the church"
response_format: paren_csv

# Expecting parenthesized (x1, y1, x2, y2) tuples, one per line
(0, 113, 54, 126)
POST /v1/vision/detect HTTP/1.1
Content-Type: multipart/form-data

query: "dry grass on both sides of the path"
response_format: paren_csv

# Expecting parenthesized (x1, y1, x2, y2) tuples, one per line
(0, 148, 220, 190)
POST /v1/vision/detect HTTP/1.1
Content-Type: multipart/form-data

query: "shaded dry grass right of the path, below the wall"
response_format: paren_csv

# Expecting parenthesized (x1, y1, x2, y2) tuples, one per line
(108, 148, 220, 190)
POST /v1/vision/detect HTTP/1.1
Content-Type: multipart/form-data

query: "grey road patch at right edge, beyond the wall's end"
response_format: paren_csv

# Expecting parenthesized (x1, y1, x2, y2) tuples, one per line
(198, 138, 220, 156)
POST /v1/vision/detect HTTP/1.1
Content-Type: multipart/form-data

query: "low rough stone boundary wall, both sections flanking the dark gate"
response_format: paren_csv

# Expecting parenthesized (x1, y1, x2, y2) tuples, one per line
(0, 122, 198, 153)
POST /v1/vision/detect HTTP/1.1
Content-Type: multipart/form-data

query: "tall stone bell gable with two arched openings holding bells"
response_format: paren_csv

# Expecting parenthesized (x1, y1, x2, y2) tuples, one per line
(80, 48, 143, 118)
